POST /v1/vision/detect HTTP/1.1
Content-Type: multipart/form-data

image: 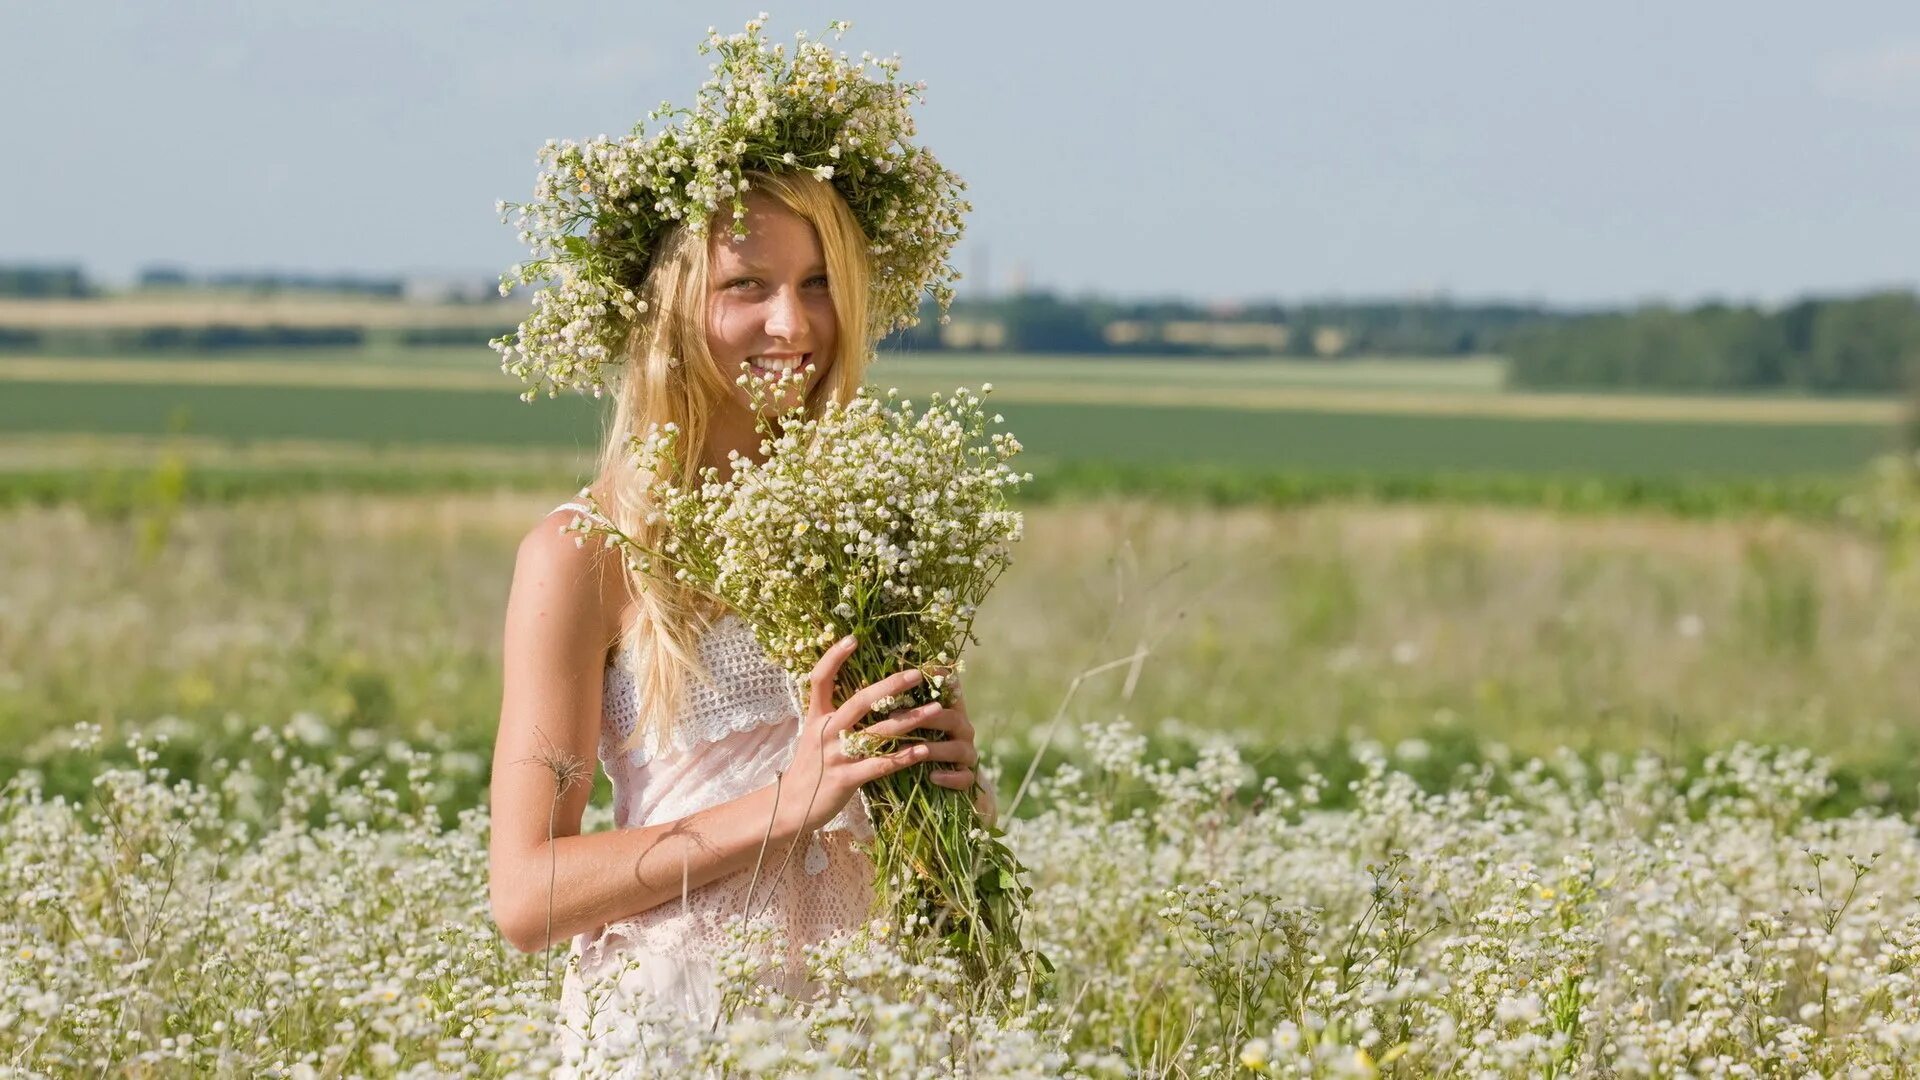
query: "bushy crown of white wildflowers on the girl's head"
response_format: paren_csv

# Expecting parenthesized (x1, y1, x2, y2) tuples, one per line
(490, 13, 972, 402)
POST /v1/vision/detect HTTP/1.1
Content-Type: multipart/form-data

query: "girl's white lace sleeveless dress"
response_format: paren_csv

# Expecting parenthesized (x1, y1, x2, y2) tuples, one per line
(555, 503, 874, 1051)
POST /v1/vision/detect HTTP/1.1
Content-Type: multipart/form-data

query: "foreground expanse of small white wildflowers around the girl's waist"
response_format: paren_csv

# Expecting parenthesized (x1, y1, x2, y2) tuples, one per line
(0, 707, 1920, 1076)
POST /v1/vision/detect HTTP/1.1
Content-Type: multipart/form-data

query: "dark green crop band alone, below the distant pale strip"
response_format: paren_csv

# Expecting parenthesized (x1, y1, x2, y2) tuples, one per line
(0, 380, 1895, 477)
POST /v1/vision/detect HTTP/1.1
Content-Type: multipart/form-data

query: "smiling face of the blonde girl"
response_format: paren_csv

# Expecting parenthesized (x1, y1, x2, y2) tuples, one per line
(707, 194, 839, 411)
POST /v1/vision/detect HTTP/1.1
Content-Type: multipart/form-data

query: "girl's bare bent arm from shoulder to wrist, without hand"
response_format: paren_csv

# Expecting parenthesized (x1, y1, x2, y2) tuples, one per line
(488, 513, 808, 951)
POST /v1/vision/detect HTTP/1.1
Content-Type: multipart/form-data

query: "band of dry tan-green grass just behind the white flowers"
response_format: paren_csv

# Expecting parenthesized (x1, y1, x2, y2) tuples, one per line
(0, 488, 1920, 805)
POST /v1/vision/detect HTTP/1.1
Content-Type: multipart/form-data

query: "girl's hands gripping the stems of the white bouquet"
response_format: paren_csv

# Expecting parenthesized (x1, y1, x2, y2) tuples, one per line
(780, 636, 979, 832)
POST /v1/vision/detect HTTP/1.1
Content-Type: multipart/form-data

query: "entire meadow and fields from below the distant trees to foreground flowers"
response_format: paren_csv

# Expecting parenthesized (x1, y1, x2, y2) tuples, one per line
(0, 350, 1920, 1078)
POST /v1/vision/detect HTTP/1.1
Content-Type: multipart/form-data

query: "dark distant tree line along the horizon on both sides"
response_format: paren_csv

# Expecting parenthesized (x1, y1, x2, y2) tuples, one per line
(11, 265, 1920, 400)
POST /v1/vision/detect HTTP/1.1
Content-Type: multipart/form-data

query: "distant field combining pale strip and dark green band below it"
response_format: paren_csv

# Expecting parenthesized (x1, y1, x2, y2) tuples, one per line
(0, 350, 1897, 477)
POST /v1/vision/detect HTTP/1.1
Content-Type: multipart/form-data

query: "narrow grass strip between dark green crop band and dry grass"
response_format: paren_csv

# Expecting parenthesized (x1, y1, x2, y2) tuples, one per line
(0, 447, 1864, 523)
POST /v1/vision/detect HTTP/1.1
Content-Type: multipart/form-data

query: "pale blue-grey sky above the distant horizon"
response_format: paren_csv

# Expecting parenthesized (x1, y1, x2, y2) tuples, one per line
(0, 0, 1920, 306)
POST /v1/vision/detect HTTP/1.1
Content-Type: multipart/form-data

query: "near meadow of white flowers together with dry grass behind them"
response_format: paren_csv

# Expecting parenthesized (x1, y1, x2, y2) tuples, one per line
(0, 484, 1920, 1078)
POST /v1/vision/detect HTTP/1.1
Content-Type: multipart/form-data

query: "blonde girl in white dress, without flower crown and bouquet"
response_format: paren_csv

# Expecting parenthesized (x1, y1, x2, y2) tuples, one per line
(490, 171, 995, 1038)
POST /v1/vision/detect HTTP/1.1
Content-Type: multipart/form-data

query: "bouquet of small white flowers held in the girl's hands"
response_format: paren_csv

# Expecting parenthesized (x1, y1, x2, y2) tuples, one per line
(593, 373, 1052, 994)
